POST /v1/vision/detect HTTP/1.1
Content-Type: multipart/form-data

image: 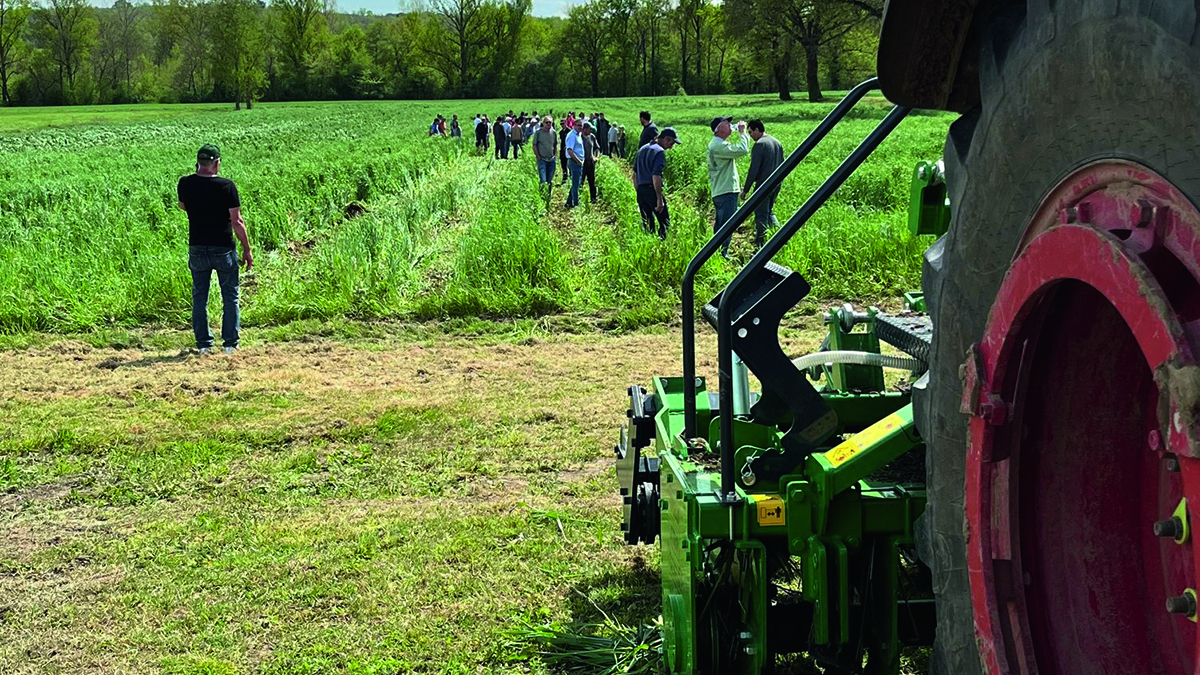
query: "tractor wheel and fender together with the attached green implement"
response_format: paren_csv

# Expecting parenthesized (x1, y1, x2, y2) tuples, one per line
(616, 0, 1200, 675)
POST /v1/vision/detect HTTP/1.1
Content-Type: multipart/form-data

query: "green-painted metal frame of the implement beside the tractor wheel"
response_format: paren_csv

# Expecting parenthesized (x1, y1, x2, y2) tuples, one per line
(628, 295, 932, 675)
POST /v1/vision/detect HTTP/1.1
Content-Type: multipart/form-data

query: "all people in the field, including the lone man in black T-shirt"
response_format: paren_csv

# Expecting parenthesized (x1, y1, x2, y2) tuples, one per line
(178, 110, 784, 354)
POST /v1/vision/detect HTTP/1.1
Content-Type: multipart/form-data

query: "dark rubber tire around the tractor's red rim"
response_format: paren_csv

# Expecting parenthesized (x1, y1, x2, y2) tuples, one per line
(916, 0, 1200, 675)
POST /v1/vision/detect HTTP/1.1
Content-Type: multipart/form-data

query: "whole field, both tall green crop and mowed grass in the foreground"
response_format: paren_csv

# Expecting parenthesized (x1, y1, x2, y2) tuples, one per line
(0, 97, 949, 675)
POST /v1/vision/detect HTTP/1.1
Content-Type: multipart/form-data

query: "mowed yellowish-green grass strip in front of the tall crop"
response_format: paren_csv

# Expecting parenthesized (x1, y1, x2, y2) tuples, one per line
(0, 324, 844, 675)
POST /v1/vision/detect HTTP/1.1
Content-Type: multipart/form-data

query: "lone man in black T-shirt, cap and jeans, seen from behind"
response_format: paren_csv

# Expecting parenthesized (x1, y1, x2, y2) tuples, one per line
(176, 144, 254, 354)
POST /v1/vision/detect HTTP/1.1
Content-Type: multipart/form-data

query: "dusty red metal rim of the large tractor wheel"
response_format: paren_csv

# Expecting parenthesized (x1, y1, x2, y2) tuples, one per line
(962, 161, 1200, 675)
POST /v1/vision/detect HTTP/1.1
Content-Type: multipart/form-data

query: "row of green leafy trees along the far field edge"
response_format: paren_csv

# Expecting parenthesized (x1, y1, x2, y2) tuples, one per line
(0, 0, 882, 108)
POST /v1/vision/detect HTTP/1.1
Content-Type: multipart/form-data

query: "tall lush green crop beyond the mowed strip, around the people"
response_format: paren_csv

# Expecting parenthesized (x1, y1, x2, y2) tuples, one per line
(0, 97, 949, 334)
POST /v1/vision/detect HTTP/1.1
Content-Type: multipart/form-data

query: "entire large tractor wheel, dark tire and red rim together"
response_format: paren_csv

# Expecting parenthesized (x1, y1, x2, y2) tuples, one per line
(917, 0, 1200, 675)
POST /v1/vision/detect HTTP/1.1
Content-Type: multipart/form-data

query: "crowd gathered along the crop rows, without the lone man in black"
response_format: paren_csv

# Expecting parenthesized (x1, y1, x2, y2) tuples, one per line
(430, 110, 784, 257)
